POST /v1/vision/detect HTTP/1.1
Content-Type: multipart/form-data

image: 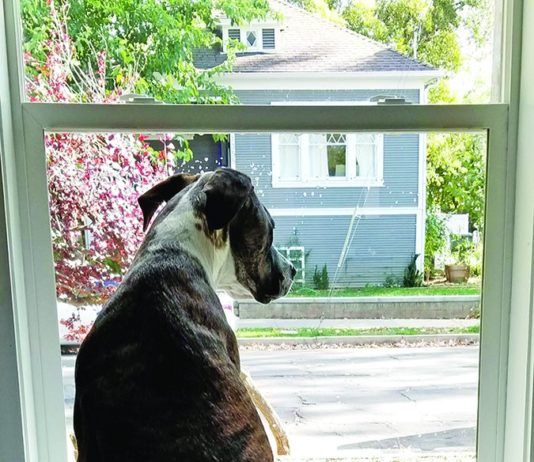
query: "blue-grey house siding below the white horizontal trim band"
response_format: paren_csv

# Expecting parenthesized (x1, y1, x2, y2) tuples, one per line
(274, 215, 416, 287)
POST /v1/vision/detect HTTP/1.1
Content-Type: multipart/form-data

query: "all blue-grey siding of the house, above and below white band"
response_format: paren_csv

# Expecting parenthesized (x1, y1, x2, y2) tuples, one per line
(233, 89, 424, 287)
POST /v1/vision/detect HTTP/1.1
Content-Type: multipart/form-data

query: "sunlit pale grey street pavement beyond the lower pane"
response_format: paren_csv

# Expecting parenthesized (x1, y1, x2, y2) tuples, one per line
(63, 346, 478, 457)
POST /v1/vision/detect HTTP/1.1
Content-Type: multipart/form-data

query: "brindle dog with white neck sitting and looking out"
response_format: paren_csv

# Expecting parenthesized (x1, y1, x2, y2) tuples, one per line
(74, 168, 296, 462)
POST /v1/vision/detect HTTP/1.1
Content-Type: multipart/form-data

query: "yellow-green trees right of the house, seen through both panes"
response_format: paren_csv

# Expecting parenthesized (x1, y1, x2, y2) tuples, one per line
(343, 0, 491, 235)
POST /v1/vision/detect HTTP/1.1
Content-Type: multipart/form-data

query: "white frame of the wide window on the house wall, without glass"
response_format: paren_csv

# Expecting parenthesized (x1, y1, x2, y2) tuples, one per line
(271, 132, 384, 188)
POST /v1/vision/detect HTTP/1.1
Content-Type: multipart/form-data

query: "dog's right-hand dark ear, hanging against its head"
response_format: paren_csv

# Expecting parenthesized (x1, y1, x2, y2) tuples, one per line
(203, 168, 253, 231)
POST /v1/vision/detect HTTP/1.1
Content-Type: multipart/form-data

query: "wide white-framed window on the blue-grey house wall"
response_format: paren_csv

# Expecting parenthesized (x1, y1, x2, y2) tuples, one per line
(272, 133, 383, 187)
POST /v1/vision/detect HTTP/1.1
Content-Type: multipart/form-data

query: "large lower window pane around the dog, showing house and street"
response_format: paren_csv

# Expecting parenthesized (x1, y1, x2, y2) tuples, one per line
(45, 127, 486, 462)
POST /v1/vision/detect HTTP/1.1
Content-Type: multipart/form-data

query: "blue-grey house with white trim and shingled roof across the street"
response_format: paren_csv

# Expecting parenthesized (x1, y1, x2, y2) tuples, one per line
(192, 0, 440, 286)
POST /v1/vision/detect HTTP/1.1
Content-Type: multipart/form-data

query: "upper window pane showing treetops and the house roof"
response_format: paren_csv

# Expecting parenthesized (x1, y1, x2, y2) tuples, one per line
(21, 0, 501, 104)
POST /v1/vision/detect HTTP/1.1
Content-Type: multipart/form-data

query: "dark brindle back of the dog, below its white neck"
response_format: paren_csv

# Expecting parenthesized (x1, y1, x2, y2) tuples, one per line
(74, 246, 272, 462)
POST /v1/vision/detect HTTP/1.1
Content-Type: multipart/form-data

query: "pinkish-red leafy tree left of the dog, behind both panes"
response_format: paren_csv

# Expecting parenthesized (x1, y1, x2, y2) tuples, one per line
(25, 4, 174, 310)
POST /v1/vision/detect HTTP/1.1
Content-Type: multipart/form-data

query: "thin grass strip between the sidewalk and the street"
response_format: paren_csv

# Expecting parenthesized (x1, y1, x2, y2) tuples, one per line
(237, 326, 480, 338)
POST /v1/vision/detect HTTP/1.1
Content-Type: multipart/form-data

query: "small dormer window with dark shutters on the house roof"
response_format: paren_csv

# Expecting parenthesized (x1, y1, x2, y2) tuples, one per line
(223, 23, 279, 53)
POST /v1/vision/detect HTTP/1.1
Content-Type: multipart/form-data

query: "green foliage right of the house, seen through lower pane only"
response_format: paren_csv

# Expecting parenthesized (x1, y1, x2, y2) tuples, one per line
(427, 133, 486, 230)
